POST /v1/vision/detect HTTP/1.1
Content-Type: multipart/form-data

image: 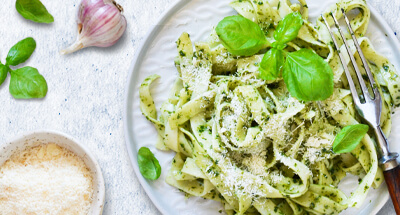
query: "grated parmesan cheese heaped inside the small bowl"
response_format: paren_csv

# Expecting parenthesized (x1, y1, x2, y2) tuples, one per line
(0, 143, 93, 215)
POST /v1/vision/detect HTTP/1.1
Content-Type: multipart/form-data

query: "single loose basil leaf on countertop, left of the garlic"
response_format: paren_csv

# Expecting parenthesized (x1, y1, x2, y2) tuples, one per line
(15, 0, 54, 23)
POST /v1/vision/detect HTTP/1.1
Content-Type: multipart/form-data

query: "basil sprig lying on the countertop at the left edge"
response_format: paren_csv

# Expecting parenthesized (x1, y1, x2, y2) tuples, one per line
(0, 37, 47, 99)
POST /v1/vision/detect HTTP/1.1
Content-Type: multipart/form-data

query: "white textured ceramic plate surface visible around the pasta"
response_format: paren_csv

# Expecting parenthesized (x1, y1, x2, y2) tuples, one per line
(124, 0, 400, 215)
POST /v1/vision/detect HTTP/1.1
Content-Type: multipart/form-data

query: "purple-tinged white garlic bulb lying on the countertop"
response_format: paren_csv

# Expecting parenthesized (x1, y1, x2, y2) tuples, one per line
(61, 0, 127, 54)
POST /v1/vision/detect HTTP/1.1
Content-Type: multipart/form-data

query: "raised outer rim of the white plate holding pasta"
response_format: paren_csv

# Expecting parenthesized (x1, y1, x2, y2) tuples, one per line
(122, 0, 400, 214)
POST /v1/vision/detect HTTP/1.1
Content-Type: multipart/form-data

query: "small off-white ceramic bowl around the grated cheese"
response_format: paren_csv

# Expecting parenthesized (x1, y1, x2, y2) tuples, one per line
(0, 130, 105, 215)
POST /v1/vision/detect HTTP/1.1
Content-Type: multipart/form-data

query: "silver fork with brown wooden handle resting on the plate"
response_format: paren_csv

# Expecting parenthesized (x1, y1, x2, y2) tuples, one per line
(321, 9, 400, 214)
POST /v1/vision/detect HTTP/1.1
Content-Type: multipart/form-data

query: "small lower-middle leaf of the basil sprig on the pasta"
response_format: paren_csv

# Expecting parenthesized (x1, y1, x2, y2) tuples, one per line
(259, 48, 285, 81)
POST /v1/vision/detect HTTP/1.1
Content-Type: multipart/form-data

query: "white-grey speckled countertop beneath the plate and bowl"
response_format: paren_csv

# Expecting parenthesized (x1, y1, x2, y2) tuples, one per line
(0, 0, 400, 215)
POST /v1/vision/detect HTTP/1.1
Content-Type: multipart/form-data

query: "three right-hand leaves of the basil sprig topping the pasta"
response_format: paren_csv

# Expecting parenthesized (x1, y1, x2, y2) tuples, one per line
(259, 12, 333, 101)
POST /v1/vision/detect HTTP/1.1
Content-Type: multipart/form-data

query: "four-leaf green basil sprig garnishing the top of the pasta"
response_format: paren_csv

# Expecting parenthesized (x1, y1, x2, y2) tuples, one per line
(215, 12, 333, 101)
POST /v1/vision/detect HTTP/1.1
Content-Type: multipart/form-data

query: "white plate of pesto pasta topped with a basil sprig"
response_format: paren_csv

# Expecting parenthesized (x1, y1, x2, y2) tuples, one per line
(124, 0, 400, 214)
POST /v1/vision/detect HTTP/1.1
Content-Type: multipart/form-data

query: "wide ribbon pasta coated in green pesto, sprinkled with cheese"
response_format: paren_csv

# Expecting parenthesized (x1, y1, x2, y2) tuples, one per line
(140, 0, 400, 215)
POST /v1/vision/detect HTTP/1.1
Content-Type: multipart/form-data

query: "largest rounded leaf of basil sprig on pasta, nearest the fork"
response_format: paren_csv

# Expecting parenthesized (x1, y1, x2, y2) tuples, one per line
(282, 49, 333, 101)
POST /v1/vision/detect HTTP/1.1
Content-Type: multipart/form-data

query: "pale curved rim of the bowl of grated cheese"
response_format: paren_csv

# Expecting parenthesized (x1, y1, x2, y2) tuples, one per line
(0, 129, 105, 215)
